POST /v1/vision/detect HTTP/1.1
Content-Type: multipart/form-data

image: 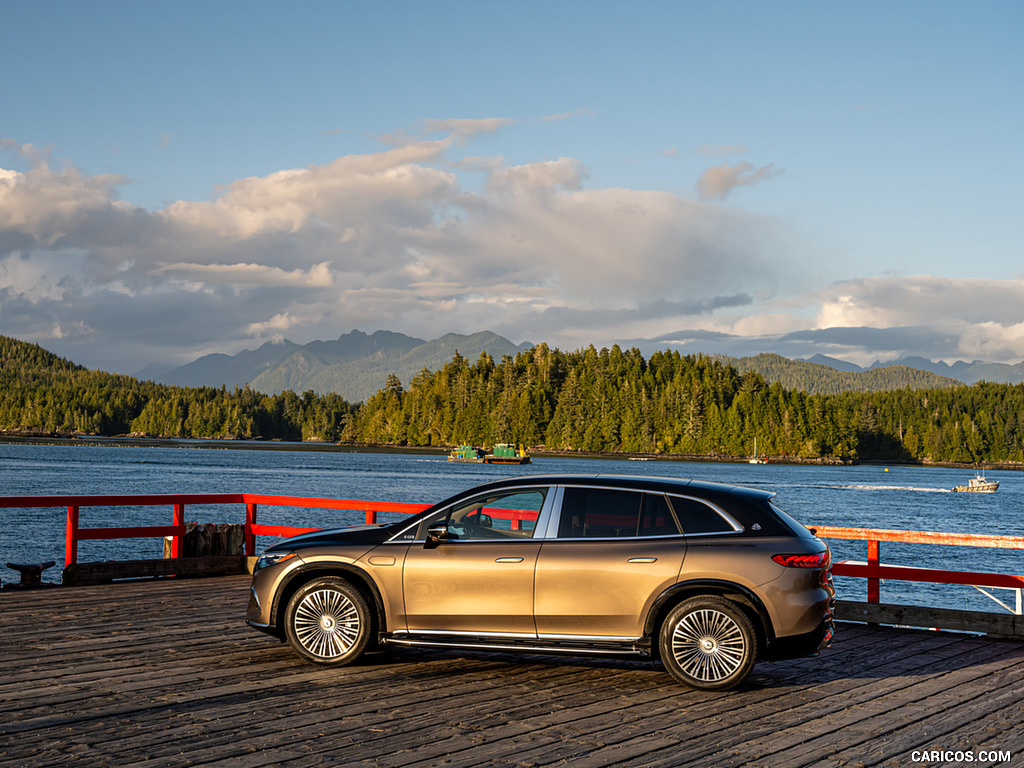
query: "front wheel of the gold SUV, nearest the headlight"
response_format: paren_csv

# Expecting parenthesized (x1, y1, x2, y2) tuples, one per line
(285, 577, 373, 667)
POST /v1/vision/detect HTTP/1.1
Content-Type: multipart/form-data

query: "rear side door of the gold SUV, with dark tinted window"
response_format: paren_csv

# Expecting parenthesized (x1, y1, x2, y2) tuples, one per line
(535, 486, 686, 640)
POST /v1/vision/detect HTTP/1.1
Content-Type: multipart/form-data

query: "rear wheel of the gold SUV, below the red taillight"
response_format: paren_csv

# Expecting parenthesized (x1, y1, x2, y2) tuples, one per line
(658, 597, 758, 690)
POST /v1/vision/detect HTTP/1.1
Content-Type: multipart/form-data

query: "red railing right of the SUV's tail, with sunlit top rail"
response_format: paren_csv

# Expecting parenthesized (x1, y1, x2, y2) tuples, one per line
(811, 525, 1024, 603)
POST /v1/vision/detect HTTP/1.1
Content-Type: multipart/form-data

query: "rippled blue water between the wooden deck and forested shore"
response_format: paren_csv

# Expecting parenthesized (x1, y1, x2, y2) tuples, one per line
(0, 441, 1024, 610)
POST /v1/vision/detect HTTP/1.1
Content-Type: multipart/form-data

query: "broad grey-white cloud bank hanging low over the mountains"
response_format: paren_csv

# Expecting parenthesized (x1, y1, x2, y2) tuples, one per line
(0, 124, 1024, 372)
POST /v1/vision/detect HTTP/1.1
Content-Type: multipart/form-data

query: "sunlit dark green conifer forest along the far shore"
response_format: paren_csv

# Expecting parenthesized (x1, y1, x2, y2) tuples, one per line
(0, 337, 1024, 463)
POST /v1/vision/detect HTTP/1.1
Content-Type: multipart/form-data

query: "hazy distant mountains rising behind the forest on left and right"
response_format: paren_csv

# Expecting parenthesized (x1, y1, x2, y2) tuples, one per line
(136, 331, 1024, 402)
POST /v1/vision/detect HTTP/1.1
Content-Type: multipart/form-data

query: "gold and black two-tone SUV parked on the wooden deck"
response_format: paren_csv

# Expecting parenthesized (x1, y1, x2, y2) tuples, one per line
(246, 475, 835, 690)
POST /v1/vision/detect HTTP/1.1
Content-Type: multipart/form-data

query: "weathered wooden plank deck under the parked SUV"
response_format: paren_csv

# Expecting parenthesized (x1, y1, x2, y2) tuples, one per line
(0, 577, 1024, 768)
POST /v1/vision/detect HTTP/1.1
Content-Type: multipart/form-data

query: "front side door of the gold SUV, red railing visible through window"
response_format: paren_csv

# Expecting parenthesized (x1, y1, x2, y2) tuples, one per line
(402, 486, 548, 637)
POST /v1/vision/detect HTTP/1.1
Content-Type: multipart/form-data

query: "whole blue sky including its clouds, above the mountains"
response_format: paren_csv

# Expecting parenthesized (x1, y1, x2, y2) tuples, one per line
(0, 0, 1024, 373)
